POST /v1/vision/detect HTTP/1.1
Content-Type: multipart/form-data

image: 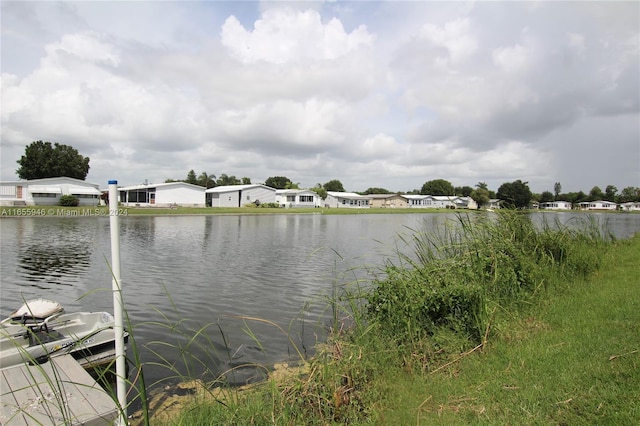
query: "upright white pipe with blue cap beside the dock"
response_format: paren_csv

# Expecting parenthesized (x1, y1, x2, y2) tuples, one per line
(109, 180, 127, 426)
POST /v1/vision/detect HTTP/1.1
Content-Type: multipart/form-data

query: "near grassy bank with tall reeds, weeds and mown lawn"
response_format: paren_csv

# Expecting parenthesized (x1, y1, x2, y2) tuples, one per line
(119, 211, 640, 426)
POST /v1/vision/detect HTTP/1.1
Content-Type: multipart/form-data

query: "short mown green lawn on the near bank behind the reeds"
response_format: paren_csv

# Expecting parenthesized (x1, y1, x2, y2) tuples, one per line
(375, 235, 640, 425)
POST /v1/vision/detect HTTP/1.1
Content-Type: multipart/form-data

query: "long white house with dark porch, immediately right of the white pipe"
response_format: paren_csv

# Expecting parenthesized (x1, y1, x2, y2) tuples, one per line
(118, 182, 205, 207)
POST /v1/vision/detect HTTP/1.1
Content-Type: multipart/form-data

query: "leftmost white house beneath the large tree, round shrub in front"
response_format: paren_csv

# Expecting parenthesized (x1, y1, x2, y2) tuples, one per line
(0, 177, 101, 206)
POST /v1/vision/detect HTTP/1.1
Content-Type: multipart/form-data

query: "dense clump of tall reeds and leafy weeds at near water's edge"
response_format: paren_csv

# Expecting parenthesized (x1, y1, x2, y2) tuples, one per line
(367, 212, 611, 352)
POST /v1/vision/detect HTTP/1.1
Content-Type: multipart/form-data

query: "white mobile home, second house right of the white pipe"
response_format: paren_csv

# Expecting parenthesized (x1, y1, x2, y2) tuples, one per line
(205, 184, 276, 207)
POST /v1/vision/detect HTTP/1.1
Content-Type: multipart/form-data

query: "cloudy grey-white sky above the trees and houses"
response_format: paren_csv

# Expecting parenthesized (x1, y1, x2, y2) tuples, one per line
(0, 0, 640, 193)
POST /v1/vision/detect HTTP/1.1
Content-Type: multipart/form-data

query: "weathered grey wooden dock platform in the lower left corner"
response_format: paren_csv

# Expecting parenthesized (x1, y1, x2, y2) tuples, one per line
(0, 355, 119, 426)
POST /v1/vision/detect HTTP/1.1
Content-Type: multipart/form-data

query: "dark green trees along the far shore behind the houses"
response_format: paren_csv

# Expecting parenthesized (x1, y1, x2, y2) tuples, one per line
(16, 140, 640, 208)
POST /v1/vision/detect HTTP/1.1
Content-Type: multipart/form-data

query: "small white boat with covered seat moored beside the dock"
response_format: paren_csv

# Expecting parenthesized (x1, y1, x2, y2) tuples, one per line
(0, 299, 128, 369)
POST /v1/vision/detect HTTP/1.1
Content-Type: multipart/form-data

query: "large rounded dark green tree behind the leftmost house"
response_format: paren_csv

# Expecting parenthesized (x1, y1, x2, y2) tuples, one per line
(16, 141, 89, 180)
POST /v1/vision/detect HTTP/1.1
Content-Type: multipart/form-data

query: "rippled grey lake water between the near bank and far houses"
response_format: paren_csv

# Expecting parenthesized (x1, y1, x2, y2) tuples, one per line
(0, 213, 640, 394)
